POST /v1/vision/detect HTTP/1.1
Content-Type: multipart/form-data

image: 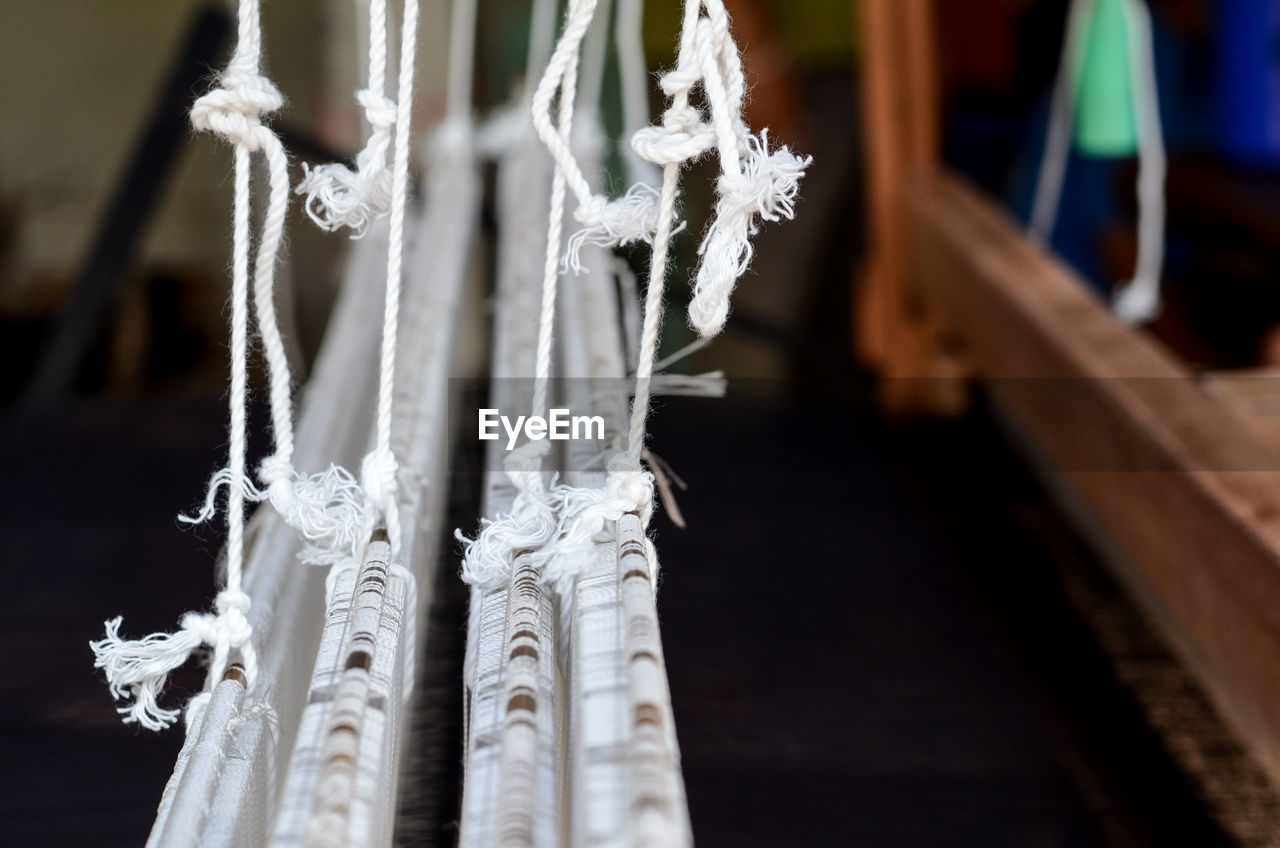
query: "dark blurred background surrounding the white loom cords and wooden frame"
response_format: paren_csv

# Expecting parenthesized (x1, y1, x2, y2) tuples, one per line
(0, 0, 1280, 847)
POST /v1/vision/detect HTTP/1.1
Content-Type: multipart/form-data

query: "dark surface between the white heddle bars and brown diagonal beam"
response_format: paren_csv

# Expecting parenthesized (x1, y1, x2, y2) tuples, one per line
(654, 400, 1228, 847)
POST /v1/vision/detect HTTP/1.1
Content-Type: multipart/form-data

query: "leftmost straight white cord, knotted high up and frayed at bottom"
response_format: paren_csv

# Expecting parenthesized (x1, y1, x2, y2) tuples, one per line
(90, 0, 288, 730)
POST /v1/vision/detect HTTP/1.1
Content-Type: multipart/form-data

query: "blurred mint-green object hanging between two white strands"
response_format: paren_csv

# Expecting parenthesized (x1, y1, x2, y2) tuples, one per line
(1075, 0, 1138, 156)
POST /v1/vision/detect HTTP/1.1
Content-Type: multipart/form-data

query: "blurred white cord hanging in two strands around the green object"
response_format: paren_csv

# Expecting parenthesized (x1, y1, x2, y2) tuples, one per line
(1028, 0, 1166, 324)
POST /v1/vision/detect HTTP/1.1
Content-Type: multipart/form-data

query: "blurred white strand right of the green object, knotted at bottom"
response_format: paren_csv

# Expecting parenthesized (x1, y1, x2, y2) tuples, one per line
(1112, 0, 1167, 324)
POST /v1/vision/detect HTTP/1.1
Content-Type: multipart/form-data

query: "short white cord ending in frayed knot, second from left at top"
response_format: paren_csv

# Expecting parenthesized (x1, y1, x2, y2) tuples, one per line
(297, 0, 397, 238)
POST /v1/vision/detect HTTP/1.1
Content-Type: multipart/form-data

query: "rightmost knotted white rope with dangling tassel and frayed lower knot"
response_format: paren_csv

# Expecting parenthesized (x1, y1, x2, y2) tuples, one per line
(535, 0, 812, 585)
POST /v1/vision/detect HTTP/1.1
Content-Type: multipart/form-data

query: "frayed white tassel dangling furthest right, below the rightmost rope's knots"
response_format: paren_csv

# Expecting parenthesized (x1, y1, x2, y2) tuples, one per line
(689, 129, 813, 337)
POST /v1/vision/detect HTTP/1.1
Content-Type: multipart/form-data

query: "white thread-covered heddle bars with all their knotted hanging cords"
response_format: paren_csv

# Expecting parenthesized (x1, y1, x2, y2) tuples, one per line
(93, 0, 808, 847)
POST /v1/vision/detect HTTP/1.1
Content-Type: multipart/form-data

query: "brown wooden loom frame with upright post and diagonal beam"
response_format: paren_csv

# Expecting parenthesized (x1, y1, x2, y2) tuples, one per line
(855, 0, 1280, 799)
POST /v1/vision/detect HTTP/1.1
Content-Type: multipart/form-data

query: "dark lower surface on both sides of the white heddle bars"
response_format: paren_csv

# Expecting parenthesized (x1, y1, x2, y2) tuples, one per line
(0, 389, 1225, 847)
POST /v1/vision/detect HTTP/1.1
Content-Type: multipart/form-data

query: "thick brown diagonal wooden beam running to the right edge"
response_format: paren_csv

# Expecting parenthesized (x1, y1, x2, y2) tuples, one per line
(906, 175, 1280, 781)
